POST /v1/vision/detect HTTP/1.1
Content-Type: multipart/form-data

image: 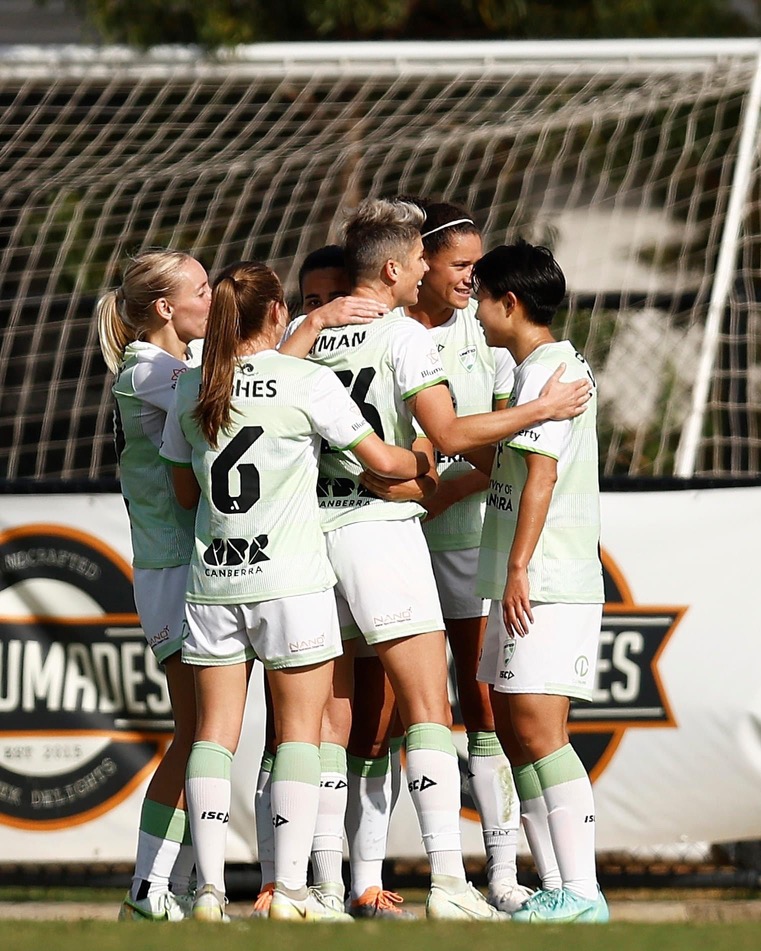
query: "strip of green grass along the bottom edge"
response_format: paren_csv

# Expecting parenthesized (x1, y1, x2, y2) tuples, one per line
(0, 920, 761, 951)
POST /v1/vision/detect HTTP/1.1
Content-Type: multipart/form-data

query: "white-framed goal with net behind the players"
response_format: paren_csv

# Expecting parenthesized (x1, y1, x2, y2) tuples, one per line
(0, 41, 761, 480)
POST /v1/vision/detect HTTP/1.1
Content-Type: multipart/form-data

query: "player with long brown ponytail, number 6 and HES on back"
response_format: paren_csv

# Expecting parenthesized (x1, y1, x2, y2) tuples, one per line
(162, 262, 429, 921)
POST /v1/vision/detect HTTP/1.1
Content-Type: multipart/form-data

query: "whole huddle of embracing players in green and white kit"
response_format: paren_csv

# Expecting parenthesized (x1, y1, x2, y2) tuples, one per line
(98, 197, 608, 922)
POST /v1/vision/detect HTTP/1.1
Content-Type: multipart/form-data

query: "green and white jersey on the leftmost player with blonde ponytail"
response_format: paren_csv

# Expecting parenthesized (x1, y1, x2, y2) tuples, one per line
(112, 340, 195, 568)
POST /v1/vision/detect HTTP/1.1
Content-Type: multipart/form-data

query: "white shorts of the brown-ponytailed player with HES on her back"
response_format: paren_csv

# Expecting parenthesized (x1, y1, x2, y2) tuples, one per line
(182, 588, 342, 670)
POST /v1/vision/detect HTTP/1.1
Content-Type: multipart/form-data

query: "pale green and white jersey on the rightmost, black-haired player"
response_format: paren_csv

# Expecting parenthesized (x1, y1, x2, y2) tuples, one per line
(476, 340, 605, 604)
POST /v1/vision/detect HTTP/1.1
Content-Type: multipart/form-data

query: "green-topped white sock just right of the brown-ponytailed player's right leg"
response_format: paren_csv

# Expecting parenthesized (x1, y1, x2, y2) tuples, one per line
(312, 743, 349, 885)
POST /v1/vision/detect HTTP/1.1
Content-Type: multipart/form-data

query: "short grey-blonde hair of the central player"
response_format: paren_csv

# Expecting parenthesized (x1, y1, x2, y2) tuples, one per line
(342, 198, 425, 284)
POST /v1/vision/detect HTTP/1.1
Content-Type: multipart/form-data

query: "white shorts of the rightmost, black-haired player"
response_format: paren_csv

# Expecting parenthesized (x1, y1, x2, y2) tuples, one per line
(477, 601, 602, 701)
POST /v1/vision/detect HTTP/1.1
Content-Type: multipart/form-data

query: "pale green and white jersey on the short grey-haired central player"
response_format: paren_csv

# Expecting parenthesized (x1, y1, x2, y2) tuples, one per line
(285, 308, 446, 532)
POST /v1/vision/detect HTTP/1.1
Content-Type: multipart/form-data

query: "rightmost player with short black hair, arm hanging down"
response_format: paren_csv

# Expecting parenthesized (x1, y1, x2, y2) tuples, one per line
(474, 241, 608, 923)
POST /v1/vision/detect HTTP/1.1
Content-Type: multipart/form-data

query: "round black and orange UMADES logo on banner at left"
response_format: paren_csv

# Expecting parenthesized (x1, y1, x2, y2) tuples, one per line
(0, 525, 172, 830)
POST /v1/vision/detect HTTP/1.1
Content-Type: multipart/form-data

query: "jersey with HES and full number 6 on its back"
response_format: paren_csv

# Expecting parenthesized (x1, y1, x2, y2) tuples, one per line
(161, 350, 372, 604)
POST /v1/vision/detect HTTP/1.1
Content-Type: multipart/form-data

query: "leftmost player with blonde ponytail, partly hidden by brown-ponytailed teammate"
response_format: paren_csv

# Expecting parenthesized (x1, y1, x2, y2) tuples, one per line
(97, 250, 211, 921)
